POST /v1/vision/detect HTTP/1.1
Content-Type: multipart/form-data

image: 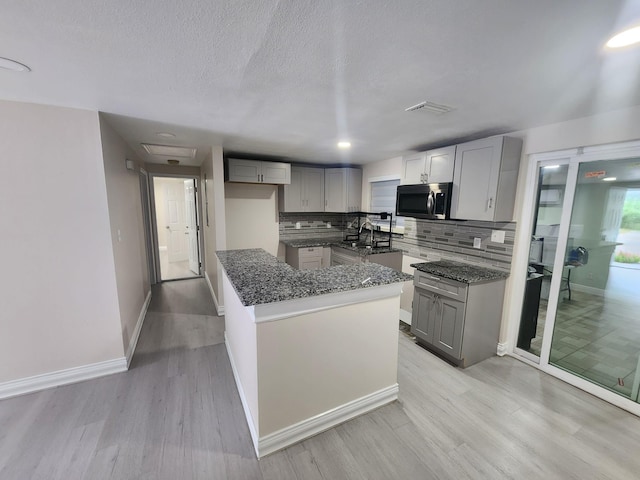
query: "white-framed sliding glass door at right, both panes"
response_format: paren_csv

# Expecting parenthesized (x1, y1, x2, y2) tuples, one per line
(514, 143, 640, 406)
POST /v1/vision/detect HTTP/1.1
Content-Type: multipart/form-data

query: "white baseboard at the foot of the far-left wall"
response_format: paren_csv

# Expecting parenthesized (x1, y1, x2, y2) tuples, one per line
(0, 357, 127, 399)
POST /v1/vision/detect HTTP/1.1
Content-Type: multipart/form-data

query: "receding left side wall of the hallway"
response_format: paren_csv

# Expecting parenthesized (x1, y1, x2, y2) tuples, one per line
(100, 117, 151, 354)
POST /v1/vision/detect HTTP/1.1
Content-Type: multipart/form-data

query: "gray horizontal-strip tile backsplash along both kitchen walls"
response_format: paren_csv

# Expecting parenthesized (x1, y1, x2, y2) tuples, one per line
(279, 213, 516, 271)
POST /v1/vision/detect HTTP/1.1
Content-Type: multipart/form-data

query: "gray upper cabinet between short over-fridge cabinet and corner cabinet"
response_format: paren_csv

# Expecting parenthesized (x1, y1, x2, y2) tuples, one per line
(279, 166, 324, 212)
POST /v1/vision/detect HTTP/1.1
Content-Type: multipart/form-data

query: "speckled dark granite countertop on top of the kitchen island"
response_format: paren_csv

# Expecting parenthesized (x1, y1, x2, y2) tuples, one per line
(216, 248, 413, 306)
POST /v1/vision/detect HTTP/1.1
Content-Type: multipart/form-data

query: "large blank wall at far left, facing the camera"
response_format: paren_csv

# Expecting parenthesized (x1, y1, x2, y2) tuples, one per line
(0, 101, 124, 383)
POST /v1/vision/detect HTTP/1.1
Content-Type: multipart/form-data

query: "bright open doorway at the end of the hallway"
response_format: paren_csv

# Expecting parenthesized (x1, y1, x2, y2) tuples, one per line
(153, 176, 201, 281)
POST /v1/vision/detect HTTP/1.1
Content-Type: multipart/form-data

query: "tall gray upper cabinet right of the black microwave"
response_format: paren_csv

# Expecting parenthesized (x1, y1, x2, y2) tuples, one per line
(451, 136, 522, 222)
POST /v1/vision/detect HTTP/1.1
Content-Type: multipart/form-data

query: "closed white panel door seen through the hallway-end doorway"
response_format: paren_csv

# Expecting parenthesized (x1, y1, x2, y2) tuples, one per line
(165, 181, 189, 262)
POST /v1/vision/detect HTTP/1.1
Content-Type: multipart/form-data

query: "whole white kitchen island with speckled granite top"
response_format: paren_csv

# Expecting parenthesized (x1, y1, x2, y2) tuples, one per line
(217, 249, 411, 457)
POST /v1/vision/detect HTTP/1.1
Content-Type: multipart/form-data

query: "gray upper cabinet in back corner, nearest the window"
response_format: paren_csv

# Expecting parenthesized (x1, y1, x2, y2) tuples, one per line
(324, 168, 362, 213)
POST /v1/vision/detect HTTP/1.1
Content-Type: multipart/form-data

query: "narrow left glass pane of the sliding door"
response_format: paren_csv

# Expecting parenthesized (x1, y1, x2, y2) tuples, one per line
(517, 164, 569, 357)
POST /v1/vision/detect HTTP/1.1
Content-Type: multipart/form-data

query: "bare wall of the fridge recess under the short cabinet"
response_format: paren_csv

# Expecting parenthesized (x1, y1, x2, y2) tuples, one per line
(224, 182, 280, 257)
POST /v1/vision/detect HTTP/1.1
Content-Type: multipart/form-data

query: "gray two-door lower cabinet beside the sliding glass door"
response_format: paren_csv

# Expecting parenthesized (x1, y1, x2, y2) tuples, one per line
(411, 271, 505, 367)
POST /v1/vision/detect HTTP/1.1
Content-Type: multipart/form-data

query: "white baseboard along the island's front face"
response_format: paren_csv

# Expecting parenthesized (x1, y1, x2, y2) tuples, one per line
(254, 383, 398, 458)
